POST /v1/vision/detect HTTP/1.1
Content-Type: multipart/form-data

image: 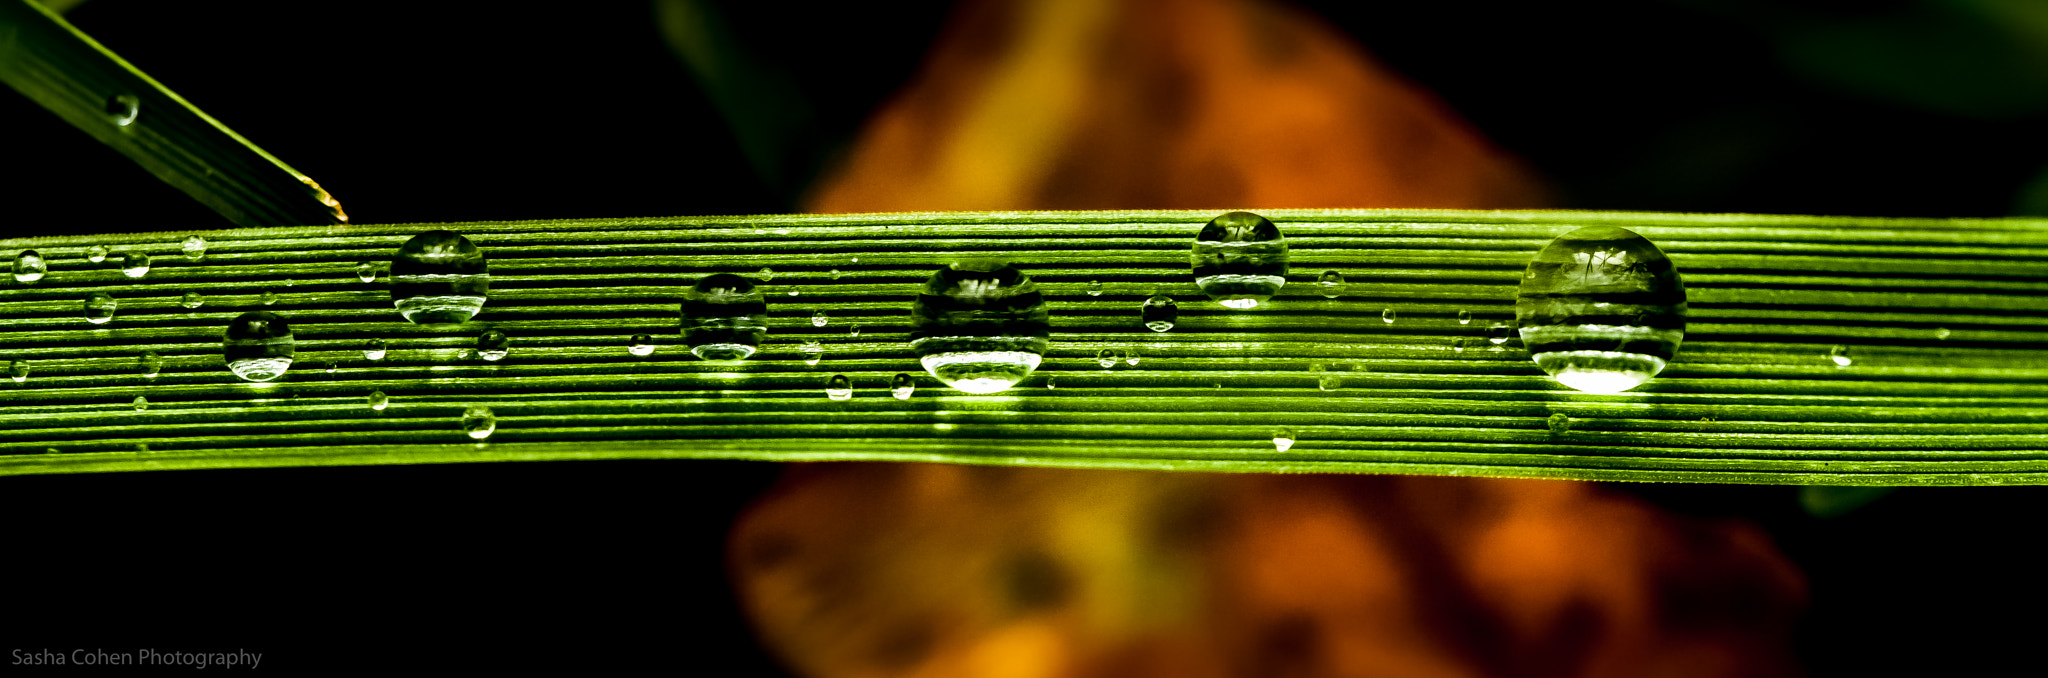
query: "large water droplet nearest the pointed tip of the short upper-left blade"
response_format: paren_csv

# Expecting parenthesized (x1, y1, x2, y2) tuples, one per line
(391, 231, 492, 324)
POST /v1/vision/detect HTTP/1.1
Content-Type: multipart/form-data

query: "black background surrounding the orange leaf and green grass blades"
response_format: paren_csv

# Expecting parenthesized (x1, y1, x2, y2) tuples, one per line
(0, 0, 2048, 676)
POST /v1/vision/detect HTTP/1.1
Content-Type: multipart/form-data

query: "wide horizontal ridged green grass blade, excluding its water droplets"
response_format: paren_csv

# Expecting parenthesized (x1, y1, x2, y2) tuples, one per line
(0, 211, 2048, 485)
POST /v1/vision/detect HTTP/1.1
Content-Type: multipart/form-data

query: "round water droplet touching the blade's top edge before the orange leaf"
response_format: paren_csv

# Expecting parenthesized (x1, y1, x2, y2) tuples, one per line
(1190, 211, 1286, 309)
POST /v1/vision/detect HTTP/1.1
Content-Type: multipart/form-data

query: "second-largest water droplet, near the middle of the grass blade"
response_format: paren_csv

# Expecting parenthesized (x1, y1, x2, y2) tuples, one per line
(909, 262, 1051, 393)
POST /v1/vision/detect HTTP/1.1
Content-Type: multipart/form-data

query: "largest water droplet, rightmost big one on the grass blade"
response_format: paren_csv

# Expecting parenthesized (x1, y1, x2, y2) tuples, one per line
(1516, 225, 1686, 393)
